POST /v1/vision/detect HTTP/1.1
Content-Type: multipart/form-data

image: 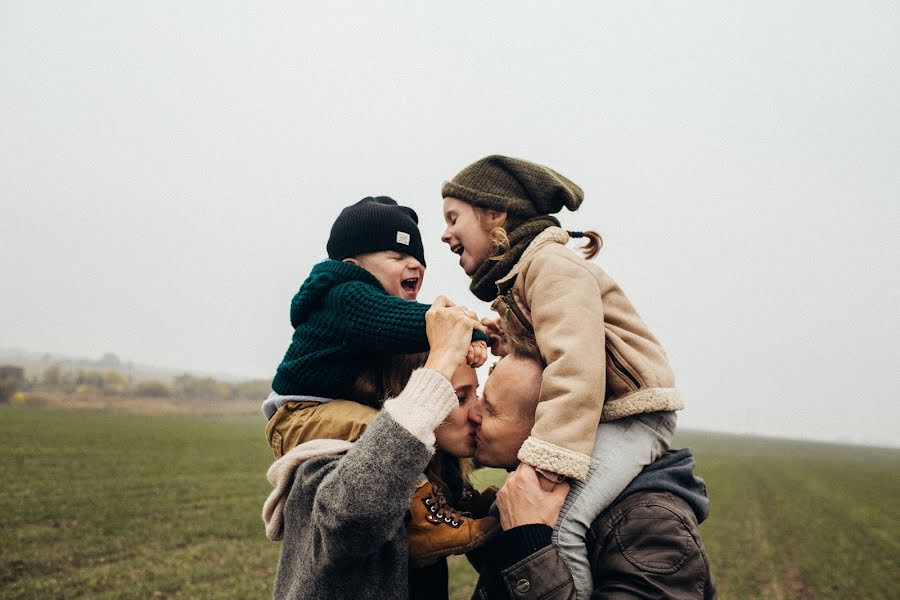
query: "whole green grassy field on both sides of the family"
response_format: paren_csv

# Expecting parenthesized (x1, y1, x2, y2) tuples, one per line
(0, 407, 900, 598)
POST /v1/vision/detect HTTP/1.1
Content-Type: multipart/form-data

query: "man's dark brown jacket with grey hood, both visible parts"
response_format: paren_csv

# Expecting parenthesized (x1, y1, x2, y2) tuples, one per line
(471, 450, 716, 600)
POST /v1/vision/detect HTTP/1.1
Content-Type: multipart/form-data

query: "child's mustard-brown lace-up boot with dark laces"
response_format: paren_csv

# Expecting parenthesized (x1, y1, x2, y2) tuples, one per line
(406, 482, 500, 567)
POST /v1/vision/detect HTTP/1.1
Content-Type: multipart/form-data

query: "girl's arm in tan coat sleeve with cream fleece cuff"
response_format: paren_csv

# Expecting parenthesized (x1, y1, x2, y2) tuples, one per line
(519, 251, 606, 480)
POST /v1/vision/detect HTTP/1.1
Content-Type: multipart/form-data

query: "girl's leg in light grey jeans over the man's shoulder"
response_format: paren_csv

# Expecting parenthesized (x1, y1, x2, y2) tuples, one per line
(553, 412, 676, 600)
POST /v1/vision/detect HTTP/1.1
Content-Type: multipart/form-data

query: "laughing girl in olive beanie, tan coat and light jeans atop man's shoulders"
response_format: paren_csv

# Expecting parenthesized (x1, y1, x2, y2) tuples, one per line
(441, 156, 683, 598)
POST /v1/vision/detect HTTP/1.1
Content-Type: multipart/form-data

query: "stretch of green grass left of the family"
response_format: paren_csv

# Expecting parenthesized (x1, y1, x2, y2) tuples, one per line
(0, 408, 278, 598)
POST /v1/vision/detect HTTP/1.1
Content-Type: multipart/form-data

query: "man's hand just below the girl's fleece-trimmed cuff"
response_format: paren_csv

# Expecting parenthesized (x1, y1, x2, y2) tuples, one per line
(497, 463, 569, 531)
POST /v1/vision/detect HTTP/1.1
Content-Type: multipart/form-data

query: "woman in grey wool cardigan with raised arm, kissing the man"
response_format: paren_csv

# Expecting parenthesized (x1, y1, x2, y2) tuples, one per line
(270, 297, 483, 599)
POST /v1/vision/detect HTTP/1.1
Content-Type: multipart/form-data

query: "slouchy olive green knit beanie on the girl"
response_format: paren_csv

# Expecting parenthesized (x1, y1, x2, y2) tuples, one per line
(441, 154, 584, 218)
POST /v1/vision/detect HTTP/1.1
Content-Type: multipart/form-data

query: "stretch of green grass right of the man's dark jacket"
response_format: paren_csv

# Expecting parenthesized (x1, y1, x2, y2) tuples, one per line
(676, 434, 900, 598)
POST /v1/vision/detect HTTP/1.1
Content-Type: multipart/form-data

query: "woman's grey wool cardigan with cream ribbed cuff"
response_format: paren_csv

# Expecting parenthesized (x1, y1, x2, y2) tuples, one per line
(274, 369, 458, 600)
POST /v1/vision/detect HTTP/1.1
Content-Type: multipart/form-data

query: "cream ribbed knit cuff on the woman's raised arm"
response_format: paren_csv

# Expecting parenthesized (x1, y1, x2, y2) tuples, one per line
(384, 369, 459, 448)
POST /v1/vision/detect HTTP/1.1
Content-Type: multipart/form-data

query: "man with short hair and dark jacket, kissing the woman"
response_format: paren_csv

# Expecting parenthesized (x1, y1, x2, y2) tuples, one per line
(469, 353, 716, 600)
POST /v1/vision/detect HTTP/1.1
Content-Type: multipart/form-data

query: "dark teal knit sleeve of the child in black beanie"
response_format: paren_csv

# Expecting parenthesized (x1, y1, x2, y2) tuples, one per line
(325, 282, 487, 354)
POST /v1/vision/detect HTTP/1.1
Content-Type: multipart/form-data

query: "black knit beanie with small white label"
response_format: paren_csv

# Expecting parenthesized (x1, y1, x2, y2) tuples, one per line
(327, 196, 425, 267)
